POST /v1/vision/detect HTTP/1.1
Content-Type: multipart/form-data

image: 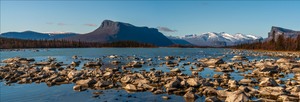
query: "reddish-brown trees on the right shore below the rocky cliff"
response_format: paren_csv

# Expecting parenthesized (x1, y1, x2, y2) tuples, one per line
(233, 34, 300, 51)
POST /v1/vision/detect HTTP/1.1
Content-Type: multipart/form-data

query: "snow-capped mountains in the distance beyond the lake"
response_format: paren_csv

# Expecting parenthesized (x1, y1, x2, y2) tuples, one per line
(181, 32, 263, 47)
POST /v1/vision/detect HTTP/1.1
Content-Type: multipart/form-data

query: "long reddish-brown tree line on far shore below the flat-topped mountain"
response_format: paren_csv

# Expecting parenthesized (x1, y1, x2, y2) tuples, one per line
(0, 37, 156, 49)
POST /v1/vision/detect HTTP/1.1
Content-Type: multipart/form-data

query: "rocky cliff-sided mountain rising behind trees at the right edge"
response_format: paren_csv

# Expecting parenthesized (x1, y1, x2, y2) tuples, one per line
(267, 26, 300, 41)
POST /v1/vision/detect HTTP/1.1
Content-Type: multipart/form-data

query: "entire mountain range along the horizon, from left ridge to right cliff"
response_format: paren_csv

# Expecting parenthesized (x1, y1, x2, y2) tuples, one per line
(0, 20, 300, 47)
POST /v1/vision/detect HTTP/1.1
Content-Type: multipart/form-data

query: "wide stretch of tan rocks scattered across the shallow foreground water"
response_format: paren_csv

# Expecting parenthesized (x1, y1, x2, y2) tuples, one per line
(0, 50, 300, 102)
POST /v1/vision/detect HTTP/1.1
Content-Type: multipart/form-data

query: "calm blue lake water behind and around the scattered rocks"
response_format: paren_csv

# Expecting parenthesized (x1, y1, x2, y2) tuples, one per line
(0, 48, 286, 102)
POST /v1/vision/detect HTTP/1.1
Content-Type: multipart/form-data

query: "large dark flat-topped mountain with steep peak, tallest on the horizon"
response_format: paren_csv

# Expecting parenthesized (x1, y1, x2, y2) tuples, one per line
(65, 20, 173, 46)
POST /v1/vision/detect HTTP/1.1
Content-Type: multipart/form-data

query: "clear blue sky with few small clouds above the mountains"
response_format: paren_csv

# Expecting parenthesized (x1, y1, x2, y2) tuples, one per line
(0, 0, 300, 37)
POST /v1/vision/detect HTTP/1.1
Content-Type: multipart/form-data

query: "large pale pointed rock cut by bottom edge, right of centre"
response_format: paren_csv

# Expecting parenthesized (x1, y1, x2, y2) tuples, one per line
(225, 90, 250, 102)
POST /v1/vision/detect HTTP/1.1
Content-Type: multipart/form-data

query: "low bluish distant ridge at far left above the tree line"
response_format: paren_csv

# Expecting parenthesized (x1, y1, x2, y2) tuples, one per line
(0, 31, 78, 40)
